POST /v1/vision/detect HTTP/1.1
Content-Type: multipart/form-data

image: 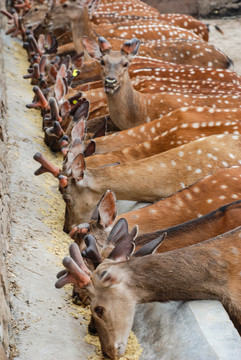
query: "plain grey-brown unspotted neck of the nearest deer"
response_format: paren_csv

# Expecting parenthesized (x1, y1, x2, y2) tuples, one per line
(120, 240, 228, 303)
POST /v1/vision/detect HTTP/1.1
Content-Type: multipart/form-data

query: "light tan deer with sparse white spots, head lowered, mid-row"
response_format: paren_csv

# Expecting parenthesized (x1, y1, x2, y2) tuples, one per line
(34, 135, 240, 232)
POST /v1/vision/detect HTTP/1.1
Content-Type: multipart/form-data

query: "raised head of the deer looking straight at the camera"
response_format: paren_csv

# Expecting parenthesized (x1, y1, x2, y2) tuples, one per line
(83, 37, 140, 95)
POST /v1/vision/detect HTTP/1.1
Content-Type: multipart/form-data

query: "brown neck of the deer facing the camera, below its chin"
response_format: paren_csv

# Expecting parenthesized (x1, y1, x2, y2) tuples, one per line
(107, 72, 147, 130)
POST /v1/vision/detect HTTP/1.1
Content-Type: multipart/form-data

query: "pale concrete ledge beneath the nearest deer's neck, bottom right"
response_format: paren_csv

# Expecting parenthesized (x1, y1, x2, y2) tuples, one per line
(133, 300, 241, 360)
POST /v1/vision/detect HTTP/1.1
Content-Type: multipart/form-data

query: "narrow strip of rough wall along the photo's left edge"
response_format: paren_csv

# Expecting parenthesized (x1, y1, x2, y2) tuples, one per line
(0, 0, 11, 360)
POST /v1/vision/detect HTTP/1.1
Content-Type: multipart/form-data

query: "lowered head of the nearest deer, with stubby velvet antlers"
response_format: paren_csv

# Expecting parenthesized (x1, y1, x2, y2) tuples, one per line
(55, 233, 166, 359)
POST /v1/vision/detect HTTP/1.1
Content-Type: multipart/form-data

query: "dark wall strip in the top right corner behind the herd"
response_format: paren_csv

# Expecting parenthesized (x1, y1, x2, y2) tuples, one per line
(143, 0, 241, 16)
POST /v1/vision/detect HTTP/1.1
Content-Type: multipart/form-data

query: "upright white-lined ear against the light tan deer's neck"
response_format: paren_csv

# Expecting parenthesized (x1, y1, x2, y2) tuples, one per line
(98, 190, 117, 228)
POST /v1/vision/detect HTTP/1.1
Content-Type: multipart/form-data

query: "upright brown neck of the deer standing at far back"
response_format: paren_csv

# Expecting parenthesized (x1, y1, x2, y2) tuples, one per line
(70, 7, 96, 54)
